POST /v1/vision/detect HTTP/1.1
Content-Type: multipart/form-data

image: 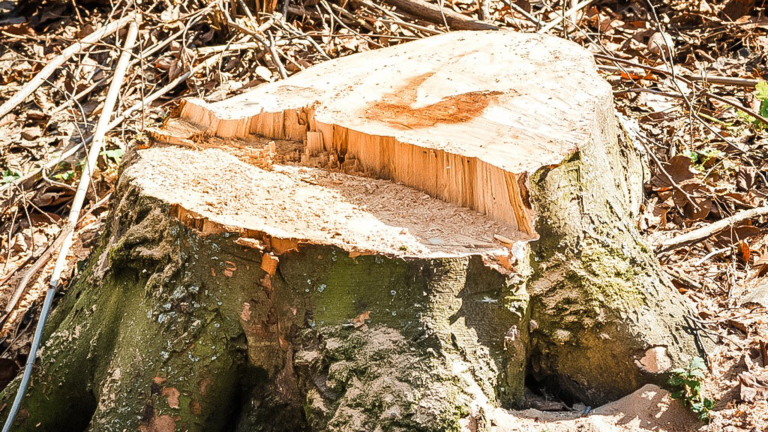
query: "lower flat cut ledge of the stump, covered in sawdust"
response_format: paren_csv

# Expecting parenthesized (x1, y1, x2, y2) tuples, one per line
(124, 146, 521, 256)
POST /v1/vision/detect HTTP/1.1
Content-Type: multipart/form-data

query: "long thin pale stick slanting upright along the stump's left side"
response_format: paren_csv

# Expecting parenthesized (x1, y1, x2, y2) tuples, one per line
(3, 21, 139, 432)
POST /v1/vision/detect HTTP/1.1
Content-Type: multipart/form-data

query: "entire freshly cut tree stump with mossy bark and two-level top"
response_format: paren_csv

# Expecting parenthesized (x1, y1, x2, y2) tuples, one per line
(2, 32, 708, 432)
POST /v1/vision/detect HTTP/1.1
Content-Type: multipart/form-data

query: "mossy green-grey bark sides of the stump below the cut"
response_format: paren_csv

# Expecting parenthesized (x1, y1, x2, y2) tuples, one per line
(0, 121, 696, 432)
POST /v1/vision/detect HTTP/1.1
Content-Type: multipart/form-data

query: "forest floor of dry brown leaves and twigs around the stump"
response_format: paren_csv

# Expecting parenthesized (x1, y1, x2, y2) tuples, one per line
(0, 0, 768, 431)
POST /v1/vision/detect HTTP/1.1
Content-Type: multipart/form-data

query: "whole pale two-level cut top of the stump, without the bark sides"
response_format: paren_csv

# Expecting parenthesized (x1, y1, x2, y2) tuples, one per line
(150, 32, 612, 255)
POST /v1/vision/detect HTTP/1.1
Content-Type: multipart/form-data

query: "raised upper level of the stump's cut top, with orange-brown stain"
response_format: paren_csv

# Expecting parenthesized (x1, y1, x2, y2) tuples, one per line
(181, 31, 613, 236)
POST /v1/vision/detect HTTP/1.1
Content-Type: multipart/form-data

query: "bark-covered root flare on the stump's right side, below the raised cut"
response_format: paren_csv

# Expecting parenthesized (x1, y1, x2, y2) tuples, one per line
(528, 113, 702, 405)
